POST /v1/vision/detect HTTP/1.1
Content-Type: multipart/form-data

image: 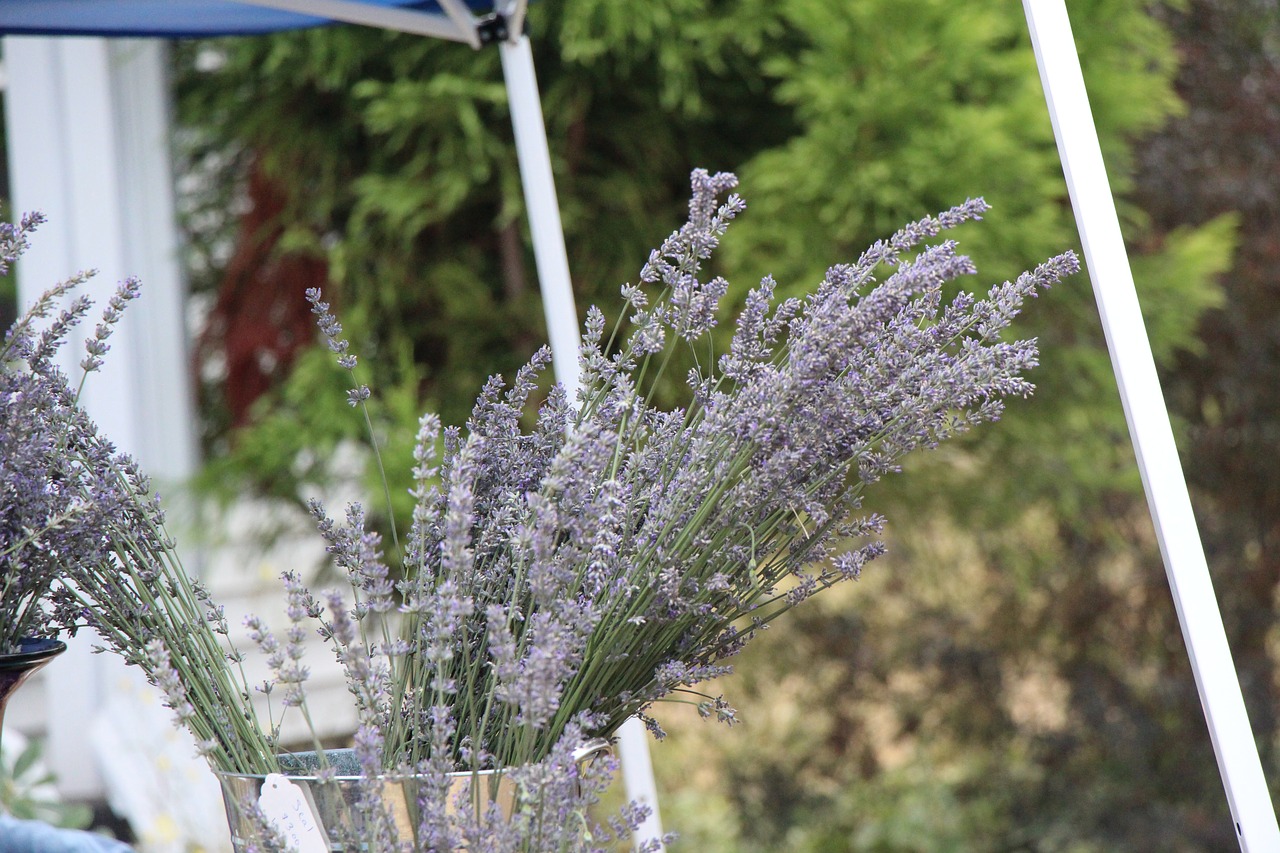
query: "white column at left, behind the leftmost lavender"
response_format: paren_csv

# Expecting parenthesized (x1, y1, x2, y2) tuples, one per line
(4, 37, 197, 798)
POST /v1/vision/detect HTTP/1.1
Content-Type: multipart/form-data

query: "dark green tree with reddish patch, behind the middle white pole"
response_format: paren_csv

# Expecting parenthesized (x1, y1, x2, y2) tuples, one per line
(178, 0, 791, 517)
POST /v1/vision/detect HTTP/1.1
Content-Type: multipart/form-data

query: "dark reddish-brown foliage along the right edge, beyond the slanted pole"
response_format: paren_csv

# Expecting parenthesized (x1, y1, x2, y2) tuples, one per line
(1135, 0, 1280, 819)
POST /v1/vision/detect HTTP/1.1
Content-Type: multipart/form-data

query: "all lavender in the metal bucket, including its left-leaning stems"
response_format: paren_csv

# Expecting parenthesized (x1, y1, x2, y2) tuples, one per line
(2, 172, 1078, 849)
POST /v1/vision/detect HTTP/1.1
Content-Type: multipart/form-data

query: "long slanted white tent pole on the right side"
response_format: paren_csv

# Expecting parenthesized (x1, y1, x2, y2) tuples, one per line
(1023, 0, 1280, 853)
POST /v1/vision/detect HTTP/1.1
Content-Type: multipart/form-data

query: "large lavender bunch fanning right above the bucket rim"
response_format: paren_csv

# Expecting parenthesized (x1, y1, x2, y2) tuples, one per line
(327, 172, 1078, 767)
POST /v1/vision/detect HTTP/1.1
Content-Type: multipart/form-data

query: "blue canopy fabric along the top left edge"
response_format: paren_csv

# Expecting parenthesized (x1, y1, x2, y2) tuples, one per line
(0, 0, 494, 37)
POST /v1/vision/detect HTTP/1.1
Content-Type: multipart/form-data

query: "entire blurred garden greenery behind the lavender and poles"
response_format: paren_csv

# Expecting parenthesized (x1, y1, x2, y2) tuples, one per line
(5, 0, 1280, 852)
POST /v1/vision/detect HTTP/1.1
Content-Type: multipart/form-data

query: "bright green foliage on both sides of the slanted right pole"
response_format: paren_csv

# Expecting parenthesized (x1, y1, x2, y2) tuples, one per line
(701, 0, 1231, 533)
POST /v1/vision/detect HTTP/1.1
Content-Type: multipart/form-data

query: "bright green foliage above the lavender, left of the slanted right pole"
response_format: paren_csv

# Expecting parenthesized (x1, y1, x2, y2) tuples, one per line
(726, 1, 1062, 282)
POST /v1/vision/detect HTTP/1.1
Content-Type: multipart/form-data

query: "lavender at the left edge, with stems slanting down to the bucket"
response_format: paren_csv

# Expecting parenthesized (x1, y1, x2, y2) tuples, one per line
(0, 214, 273, 766)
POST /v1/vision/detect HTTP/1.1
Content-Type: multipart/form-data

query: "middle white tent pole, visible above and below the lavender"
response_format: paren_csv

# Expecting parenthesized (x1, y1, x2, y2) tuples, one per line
(500, 33, 662, 847)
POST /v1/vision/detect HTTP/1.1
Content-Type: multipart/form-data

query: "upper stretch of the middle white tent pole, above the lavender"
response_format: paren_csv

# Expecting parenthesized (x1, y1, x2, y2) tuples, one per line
(499, 36, 581, 401)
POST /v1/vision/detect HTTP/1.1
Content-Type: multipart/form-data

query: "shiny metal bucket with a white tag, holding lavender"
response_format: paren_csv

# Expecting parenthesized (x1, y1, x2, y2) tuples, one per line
(215, 738, 612, 853)
